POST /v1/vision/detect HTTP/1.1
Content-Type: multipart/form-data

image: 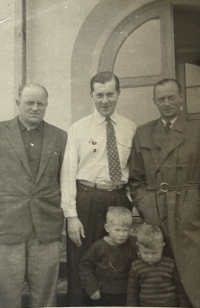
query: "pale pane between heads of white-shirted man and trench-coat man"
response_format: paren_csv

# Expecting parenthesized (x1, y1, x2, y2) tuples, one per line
(117, 87, 160, 125)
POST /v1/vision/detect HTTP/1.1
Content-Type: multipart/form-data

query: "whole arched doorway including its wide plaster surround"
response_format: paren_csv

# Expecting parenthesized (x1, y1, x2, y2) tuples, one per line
(72, 0, 200, 125)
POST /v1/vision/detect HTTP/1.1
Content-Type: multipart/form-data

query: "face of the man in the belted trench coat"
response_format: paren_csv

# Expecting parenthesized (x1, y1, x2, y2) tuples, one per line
(154, 81, 183, 121)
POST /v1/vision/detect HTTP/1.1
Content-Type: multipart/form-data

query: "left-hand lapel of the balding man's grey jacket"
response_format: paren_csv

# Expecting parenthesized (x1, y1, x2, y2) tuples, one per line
(6, 118, 32, 178)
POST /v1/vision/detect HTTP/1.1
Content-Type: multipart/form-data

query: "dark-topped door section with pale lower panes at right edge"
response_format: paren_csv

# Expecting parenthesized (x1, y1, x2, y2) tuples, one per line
(173, 5, 200, 117)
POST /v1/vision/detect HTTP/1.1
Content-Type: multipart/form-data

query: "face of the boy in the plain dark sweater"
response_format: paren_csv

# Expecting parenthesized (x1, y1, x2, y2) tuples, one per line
(105, 223, 131, 245)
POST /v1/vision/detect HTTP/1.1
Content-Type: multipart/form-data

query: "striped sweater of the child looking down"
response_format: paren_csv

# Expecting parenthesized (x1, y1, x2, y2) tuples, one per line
(127, 257, 188, 307)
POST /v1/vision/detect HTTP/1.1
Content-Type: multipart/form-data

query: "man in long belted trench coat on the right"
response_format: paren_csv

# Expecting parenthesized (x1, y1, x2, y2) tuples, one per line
(130, 79, 200, 307)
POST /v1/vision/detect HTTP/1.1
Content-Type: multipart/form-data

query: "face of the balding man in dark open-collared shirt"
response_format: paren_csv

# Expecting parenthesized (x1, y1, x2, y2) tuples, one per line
(18, 85, 47, 128)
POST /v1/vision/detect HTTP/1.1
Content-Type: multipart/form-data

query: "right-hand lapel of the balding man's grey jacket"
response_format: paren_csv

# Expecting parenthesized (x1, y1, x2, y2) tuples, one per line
(36, 122, 57, 183)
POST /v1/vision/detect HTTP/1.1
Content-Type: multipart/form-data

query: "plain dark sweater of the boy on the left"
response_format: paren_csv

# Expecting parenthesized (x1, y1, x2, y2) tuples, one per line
(79, 239, 137, 295)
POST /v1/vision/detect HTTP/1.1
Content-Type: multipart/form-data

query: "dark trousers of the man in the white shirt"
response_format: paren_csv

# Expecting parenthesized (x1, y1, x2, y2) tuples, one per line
(67, 184, 132, 307)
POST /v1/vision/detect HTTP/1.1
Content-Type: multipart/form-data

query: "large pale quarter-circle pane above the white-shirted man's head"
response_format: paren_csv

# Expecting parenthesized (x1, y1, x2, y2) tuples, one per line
(114, 19, 161, 77)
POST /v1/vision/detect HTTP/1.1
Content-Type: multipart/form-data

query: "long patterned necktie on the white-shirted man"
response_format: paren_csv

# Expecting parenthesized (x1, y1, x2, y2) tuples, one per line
(106, 117, 122, 182)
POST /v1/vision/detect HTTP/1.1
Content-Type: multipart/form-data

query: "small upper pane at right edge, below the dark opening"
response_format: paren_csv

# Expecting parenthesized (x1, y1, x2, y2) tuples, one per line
(185, 63, 200, 87)
